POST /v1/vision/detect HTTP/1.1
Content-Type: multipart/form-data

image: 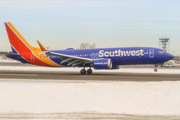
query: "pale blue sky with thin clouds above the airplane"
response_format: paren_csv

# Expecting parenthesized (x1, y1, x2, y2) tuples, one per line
(0, 0, 180, 55)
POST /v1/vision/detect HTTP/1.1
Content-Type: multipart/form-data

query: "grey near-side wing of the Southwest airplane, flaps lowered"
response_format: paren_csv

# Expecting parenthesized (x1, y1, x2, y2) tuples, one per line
(46, 51, 93, 66)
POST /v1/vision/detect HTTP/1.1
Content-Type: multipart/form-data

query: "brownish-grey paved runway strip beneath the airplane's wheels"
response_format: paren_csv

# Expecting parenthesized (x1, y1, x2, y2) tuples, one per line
(0, 71, 180, 82)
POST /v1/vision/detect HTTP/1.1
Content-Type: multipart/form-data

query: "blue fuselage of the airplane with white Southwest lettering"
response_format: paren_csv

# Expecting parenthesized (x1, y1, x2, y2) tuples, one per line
(46, 47, 174, 66)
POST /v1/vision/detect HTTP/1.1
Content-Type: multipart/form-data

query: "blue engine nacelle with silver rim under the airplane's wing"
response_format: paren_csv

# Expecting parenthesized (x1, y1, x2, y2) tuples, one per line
(93, 58, 112, 69)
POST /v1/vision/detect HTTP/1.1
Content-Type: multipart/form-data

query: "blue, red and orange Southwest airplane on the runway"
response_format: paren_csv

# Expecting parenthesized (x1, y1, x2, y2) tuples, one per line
(1, 22, 174, 74)
